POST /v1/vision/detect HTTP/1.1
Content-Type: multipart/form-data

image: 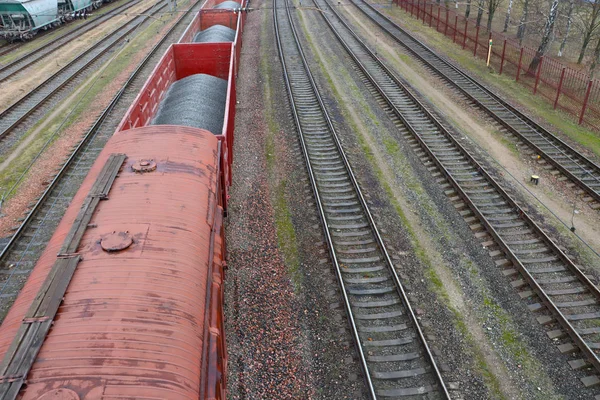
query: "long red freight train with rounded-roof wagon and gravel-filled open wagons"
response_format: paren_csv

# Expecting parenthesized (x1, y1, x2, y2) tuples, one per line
(0, 0, 245, 400)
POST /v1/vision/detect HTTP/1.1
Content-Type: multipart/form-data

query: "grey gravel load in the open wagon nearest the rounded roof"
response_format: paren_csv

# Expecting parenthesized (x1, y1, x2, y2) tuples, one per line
(151, 74, 227, 135)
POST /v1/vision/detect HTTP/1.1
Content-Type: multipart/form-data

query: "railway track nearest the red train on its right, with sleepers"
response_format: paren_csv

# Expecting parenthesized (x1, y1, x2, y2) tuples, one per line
(273, 2, 449, 398)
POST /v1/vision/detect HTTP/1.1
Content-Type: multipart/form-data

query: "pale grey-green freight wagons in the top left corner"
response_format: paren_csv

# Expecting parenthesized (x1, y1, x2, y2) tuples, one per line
(0, 0, 110, 41)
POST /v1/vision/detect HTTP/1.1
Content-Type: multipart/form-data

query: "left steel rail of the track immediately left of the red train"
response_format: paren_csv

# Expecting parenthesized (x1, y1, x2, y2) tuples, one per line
(0, 0, 203, 310)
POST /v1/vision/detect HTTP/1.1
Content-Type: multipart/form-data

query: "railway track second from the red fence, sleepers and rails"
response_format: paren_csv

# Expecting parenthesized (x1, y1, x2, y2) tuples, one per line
(313, 0, 600, 386)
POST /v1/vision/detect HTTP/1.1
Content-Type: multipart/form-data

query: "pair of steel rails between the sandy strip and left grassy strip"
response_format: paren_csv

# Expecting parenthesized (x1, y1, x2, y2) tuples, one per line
(0, 1, 168, 139)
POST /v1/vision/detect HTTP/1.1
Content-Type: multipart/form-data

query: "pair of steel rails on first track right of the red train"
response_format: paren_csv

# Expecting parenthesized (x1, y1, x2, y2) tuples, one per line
(273, 1, 450, 399)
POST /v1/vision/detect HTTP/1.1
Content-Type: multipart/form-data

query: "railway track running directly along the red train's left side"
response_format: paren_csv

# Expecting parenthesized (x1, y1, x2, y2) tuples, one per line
(0, 0, 201, 323)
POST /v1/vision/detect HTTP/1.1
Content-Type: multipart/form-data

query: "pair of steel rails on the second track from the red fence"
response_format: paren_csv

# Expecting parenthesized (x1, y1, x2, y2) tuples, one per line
(313, 0, 600, 371)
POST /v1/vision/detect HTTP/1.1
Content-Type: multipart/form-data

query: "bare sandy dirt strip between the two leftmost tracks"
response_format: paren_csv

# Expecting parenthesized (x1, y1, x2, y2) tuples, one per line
(0, 0, 162, 110)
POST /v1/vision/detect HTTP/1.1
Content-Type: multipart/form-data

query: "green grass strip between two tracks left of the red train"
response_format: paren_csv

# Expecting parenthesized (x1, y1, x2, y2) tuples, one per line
(0, 8, 176, 200)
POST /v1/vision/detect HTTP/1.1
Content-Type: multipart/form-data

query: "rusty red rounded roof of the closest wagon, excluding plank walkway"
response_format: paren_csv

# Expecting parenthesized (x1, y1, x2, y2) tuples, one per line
(0, 126, 225, 399)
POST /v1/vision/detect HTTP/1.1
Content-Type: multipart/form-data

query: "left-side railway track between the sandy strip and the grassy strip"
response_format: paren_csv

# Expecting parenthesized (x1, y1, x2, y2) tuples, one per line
(0, 1, 168, 146)
